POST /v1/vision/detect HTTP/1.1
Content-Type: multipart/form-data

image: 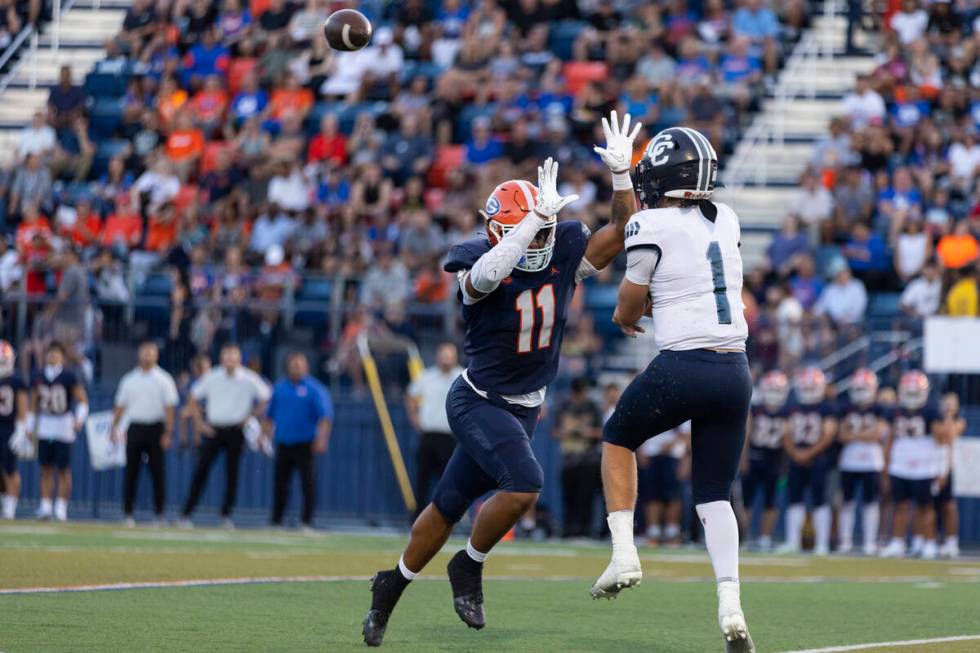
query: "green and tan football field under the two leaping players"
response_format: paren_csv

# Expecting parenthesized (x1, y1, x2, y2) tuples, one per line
(0, 522, 980, 653)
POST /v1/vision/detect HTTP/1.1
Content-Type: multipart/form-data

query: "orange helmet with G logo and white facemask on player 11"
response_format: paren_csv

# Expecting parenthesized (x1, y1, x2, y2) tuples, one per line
(482, 179, 558, 272)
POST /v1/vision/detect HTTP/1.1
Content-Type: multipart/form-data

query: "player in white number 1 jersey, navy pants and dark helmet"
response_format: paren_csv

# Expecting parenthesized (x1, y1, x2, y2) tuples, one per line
(592, 127, 755, 652)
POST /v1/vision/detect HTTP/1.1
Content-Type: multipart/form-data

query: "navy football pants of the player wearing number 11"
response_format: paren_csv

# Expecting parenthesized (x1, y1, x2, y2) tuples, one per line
(432, 376, 544, 523)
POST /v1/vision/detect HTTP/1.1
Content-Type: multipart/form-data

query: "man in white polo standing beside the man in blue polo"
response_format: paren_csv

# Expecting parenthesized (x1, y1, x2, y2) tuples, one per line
(182, 344, 272, 527)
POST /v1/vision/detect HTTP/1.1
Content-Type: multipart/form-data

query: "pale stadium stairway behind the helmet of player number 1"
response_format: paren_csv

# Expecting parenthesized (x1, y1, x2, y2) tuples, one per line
(717, 6, 874, 270)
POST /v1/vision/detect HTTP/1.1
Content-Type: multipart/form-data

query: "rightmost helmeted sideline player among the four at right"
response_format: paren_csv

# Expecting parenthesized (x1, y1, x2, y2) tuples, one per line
(881, 370, 939, 559)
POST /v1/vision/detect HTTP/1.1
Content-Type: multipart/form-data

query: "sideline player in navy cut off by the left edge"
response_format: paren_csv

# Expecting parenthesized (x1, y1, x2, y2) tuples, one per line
(0, 340, 27, 519)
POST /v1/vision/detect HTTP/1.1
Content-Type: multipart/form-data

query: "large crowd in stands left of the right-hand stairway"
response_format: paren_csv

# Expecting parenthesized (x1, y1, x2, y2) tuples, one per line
(0, 0, 808, 380)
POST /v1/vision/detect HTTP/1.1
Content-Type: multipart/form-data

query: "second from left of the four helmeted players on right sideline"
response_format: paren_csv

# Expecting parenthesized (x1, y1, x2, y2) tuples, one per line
(781, 367, 837, 555)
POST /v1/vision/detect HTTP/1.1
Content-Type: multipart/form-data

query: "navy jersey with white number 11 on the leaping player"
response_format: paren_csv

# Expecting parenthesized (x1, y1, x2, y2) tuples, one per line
(444, 221, 589, 395)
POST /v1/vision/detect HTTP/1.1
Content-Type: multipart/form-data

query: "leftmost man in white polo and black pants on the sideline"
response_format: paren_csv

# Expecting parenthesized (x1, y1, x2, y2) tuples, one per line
(109, 342, 178, 526)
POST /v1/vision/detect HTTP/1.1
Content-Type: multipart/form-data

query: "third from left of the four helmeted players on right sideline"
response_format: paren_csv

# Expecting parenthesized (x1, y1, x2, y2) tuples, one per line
(837, 368, 888, 555)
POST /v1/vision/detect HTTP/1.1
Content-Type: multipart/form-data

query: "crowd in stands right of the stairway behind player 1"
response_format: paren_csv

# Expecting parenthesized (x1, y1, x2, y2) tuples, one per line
(747, 0, 980, 369)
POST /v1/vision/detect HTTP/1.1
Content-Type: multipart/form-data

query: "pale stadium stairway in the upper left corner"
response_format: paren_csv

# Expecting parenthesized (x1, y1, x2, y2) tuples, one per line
(0, 0, 124, 165)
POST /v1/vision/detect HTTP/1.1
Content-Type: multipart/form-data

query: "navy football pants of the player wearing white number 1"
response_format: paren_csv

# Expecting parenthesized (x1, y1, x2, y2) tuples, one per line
(602, 349, 752, 504)
